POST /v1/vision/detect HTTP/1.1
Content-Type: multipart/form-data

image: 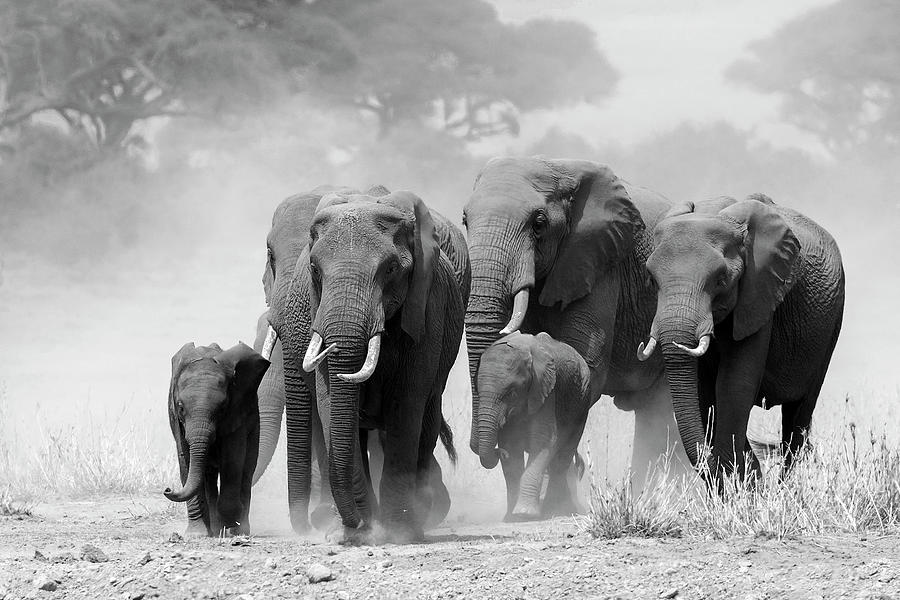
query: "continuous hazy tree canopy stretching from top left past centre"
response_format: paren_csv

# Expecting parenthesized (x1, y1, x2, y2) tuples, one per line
(0, 0, 616, 149)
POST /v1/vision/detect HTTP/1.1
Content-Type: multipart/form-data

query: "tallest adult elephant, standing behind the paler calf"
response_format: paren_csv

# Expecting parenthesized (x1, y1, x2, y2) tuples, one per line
(464, 157, 675, 502)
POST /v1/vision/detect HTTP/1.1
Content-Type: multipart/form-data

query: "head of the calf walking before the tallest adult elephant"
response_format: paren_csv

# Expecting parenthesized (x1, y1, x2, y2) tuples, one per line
(477, 331, 556, 469)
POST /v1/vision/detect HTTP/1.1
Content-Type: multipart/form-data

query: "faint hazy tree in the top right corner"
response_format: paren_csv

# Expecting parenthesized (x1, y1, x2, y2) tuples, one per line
(727, 0, 900, 154)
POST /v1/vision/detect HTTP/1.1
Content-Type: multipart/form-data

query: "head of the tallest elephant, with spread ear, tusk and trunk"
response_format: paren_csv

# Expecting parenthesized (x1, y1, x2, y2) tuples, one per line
(463, 157, 644, 452)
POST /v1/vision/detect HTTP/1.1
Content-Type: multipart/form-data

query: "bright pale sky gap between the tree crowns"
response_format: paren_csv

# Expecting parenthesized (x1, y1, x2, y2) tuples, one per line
(491, 0, 830, 149)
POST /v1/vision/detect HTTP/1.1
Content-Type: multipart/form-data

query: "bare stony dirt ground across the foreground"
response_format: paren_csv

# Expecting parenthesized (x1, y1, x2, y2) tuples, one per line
(0, 497, 900, 600)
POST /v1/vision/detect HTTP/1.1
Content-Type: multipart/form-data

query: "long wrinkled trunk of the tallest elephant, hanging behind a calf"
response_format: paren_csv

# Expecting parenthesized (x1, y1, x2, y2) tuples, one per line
(466, 223, 535, 454)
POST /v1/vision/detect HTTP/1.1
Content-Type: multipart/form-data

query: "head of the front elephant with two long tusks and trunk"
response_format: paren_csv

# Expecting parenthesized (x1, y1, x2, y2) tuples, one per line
(298, 192, 440, 527)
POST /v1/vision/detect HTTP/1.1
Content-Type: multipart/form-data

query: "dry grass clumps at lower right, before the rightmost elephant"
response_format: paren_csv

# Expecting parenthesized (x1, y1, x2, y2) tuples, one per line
(582, 425, 900, 538)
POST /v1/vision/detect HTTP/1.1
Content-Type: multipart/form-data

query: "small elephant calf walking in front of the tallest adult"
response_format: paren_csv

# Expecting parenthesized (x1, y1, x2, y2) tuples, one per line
(478, 332, 591, 521)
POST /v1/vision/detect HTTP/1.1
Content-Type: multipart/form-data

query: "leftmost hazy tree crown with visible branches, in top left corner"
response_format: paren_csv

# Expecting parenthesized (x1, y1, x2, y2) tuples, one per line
(0, 0, 352, 149)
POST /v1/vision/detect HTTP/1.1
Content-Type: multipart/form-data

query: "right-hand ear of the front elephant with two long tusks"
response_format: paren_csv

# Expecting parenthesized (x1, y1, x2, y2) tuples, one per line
(378, 191, 440, 342)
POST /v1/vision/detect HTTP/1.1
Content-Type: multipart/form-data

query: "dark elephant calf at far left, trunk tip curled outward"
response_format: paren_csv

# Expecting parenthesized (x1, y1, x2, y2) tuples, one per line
(163, 343, 269, 536)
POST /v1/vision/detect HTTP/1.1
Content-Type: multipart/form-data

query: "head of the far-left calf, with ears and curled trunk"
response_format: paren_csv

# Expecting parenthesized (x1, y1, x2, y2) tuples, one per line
(164, 343, 269, 502)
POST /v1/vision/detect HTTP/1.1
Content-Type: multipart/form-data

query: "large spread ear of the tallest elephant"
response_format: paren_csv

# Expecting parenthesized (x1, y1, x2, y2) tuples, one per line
(540, 160, 644, 308)
